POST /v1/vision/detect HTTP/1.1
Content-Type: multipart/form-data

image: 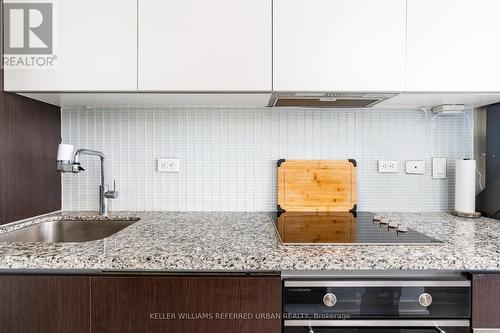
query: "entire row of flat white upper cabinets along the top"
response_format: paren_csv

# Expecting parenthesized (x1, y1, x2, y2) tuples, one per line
(4, 0, 500, 96)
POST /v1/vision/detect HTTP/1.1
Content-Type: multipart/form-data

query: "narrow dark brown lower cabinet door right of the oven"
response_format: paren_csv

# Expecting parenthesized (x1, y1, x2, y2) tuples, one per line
(472, 274, 500, 329)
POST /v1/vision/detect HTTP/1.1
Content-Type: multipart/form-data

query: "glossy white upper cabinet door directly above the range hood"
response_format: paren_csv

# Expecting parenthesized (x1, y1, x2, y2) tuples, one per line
(273, 0, 406, 91)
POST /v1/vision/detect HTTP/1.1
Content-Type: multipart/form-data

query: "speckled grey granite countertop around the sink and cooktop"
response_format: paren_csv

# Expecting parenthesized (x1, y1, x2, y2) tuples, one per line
(0, 212, 500, 271)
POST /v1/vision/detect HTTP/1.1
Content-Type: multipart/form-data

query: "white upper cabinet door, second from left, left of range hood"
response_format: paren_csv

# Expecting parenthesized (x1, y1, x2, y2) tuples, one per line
(138, 0, 272, 91)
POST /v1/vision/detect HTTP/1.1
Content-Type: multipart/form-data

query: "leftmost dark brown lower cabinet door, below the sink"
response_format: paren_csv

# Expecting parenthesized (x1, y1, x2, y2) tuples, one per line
(0, 276, 90, 333)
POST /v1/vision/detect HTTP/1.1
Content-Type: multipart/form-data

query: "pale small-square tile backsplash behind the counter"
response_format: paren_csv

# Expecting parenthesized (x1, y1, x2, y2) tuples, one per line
(62, 107, 473, 211)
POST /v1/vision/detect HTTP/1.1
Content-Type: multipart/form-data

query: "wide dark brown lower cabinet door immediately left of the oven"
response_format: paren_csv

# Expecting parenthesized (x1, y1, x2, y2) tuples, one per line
(91, 276, 281, 333)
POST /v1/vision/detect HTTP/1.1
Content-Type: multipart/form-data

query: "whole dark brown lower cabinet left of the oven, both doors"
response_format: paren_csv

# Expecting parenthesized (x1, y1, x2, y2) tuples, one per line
(0, 275, 281, 333)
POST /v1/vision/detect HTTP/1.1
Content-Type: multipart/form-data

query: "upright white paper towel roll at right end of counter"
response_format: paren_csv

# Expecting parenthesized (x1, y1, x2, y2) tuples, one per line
(455, 160, 476, 213)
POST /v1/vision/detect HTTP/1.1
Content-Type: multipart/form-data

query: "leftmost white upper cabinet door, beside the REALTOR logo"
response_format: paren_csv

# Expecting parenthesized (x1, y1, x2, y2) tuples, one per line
(4, 0, 137, 91)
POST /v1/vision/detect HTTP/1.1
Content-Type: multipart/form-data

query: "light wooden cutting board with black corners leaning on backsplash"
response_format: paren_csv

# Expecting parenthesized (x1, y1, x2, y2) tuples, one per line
(278, 160, 356, 212)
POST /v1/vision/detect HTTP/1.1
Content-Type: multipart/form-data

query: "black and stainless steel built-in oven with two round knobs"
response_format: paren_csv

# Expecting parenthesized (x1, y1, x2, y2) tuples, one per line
(283, 276, 471, 333)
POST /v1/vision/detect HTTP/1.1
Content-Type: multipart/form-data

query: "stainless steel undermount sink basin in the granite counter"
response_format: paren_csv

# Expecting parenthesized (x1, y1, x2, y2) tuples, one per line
(0, 219, 138, 242)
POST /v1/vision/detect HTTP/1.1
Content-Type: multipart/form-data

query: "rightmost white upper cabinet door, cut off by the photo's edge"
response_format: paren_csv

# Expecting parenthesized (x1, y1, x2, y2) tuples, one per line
(407, 0, 500, 92)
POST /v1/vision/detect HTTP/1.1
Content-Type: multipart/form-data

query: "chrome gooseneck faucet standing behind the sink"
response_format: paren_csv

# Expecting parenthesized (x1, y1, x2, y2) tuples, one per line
(57, 149, 118, 216)
